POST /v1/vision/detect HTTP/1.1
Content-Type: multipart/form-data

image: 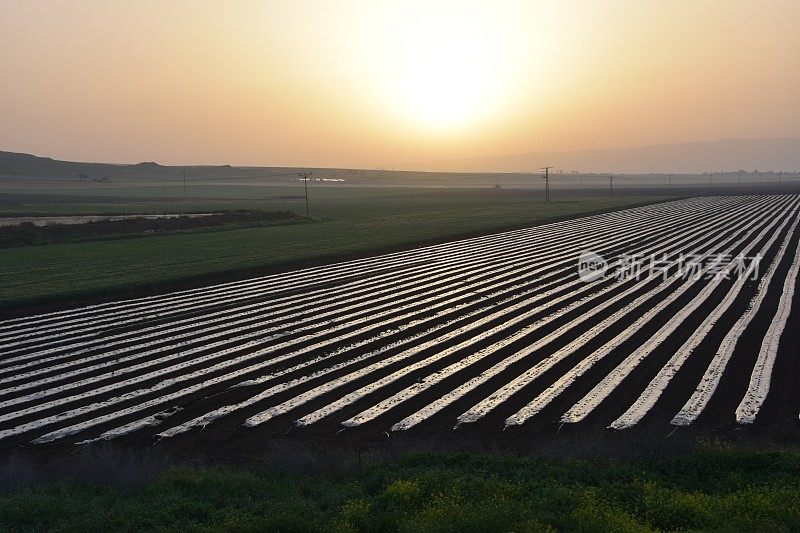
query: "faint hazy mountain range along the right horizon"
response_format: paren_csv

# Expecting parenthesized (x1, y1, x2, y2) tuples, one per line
(413, 137, 800, 174)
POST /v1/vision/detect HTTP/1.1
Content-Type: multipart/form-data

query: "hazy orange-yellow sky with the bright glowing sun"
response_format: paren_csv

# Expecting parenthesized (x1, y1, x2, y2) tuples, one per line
(0, 0, 800, 167)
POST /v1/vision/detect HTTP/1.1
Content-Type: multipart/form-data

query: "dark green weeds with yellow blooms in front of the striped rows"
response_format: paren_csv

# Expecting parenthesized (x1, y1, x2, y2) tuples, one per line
(0, 450, 800, 531)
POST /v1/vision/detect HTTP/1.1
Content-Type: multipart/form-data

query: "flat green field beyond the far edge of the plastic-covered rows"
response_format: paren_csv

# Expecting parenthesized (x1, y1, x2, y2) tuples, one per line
(0, 186, 664, 311)
